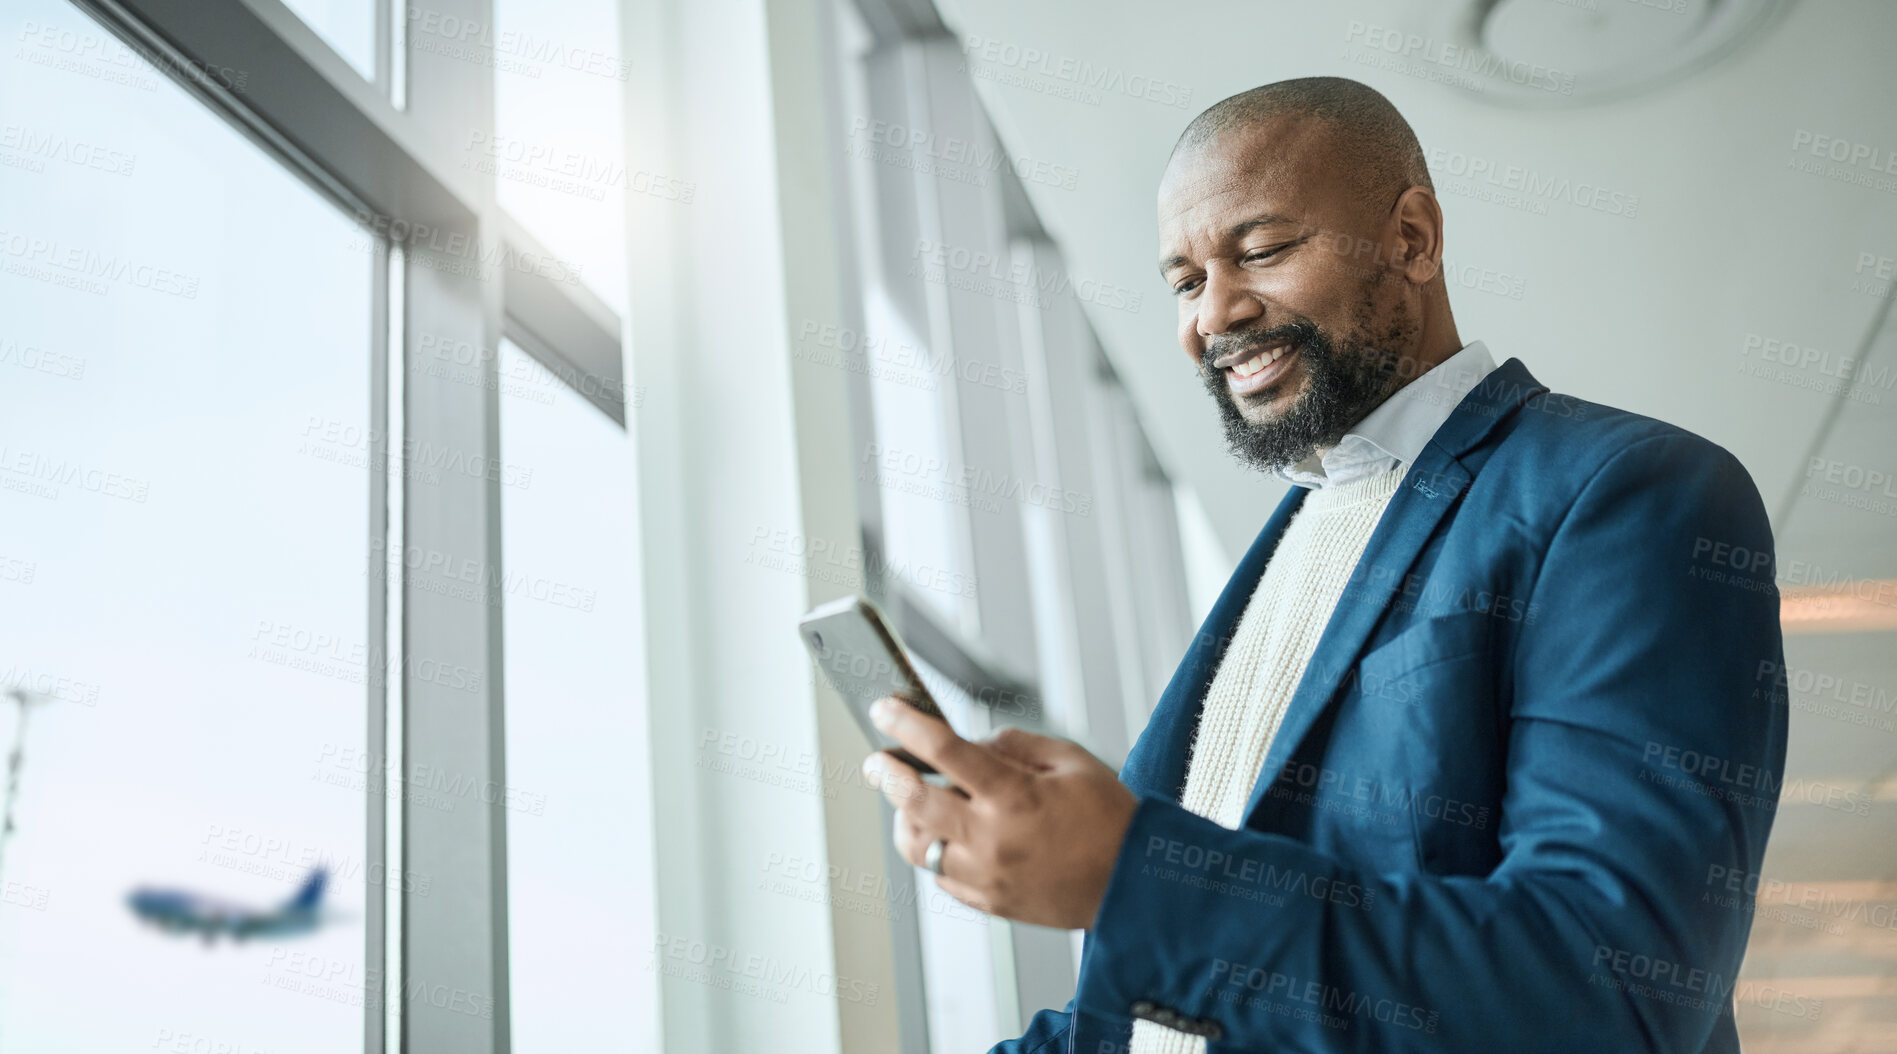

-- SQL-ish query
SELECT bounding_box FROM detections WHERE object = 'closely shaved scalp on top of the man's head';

[1172,78,1434,212]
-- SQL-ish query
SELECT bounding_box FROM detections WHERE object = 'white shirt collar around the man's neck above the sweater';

[1275,341,1495,489]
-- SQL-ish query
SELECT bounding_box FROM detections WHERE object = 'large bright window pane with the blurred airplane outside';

[0,0,373,1054]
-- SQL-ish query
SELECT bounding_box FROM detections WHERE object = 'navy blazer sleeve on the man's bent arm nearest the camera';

[1062,432,1787,1054]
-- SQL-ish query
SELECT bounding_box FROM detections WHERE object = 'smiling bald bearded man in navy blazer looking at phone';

[865,78,1787,1054]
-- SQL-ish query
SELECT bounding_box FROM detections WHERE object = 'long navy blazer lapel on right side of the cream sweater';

[1236,358,1548,821]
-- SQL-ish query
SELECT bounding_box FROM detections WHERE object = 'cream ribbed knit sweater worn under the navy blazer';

[1129,466,1404,1054]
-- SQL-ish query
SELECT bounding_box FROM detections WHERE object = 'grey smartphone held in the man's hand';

[797,597,949,775]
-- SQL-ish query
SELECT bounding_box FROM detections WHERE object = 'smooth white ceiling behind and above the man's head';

[939,0,1897,557]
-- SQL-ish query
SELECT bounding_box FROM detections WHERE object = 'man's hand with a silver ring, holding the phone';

[863,698,1138,929]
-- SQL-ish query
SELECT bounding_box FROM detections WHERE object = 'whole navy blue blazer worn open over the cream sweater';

[994,358,1787,1054]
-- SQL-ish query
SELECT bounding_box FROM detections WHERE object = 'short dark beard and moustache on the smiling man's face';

[1201,303,1413,470]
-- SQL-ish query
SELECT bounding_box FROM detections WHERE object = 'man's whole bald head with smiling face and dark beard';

[1159,78,1461,475]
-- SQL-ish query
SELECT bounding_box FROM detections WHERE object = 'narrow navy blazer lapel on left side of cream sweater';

[1119,487,1309,802]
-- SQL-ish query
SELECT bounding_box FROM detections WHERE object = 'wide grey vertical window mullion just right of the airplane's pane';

[398,0,510,1054]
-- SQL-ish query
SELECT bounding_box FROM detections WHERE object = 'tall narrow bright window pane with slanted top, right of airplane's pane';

[499,341,656,1054]
